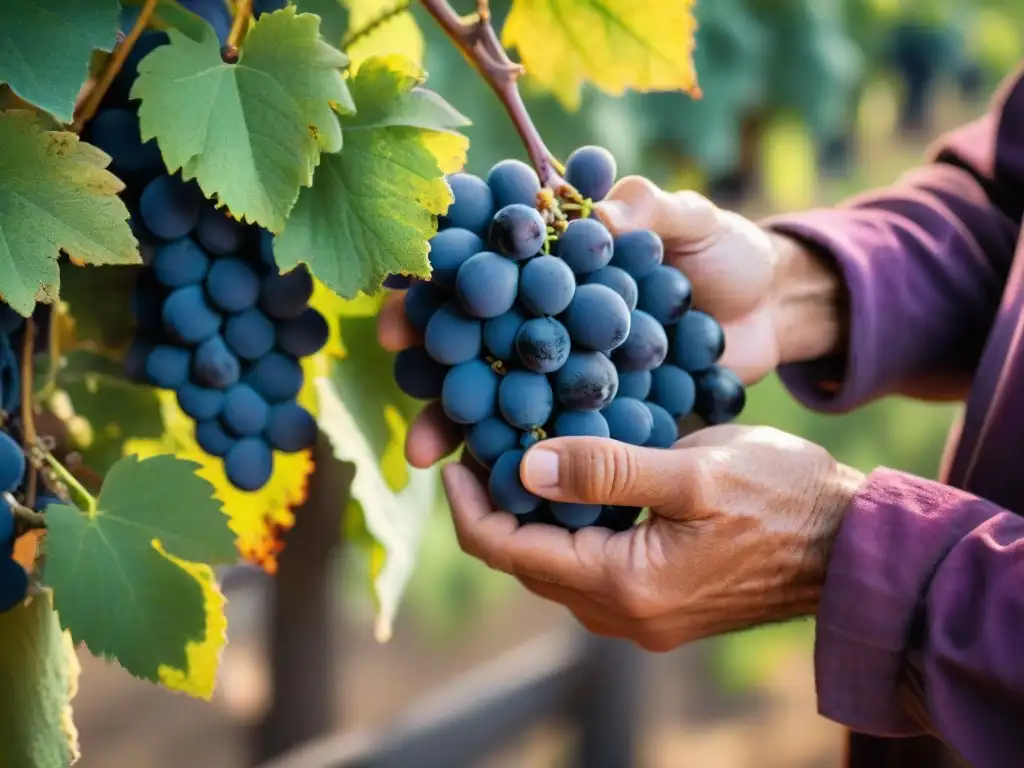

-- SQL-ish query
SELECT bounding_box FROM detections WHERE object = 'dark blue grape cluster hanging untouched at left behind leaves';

[86,32,328,490]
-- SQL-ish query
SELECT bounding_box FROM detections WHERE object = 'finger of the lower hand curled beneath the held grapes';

[442,464,611,594]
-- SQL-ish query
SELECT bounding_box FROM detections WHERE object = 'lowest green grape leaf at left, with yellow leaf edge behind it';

[44,456,238,682]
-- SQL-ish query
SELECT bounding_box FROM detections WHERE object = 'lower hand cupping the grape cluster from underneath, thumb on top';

[443,425,864,651]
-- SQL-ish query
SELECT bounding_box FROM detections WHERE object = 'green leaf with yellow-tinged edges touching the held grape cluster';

[274,55,469,298]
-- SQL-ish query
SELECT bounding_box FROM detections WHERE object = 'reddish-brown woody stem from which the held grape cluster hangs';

[422,0,565,190]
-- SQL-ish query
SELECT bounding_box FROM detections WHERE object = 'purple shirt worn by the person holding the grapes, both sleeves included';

[766,66,1024,768]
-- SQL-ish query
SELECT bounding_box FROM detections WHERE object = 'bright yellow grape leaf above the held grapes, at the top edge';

[502,0,697,111]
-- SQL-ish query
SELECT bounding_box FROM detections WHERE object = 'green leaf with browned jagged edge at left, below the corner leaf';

[0,112,141,316]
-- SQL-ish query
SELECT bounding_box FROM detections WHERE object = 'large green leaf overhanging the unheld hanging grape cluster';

[131,6,353,231]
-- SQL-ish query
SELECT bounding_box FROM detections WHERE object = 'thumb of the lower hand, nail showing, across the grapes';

[519,437,692,507]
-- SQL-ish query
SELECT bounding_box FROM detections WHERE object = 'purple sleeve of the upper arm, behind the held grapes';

[764,69,1024,412]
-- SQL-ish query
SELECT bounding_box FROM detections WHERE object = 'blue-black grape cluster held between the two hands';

[394,146,745,530]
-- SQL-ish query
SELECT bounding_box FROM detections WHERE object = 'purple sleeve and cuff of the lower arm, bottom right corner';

[815,469,1024,768]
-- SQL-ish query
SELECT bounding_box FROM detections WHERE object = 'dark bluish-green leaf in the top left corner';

[0,0,120,123]
